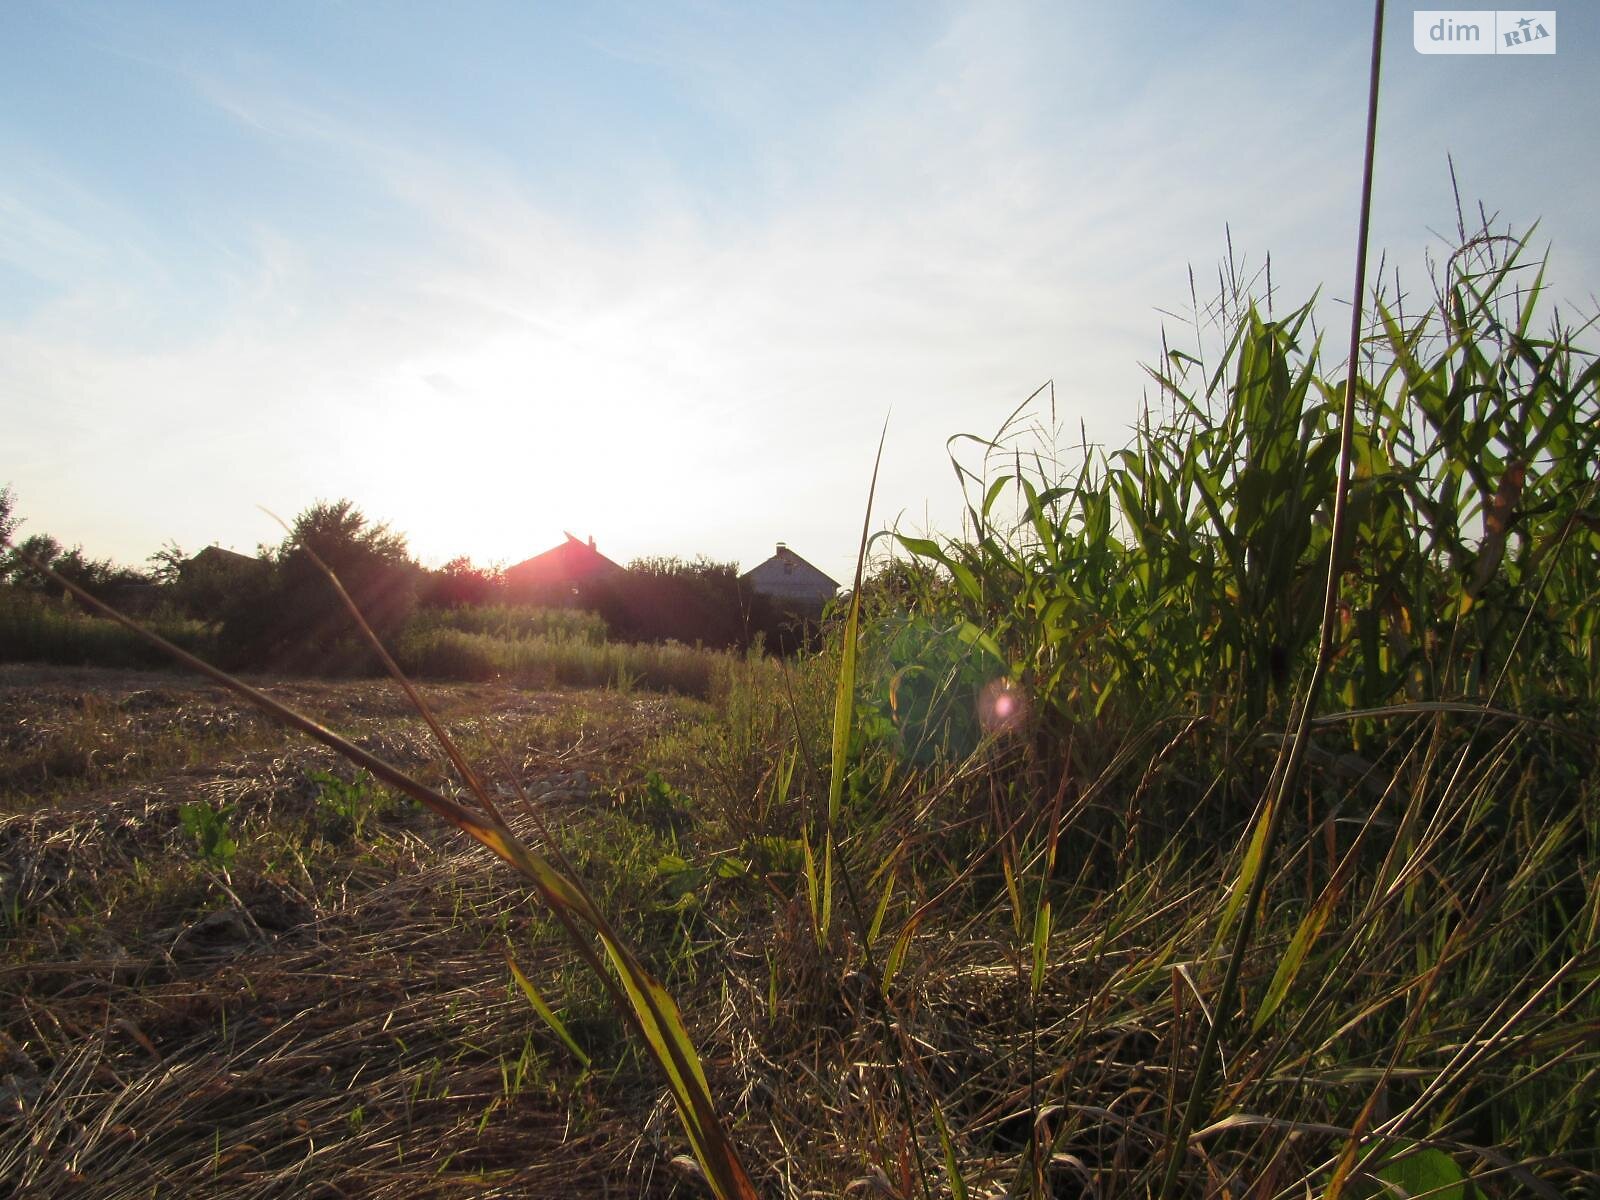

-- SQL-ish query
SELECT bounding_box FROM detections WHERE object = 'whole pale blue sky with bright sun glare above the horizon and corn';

[0,0,1600,581]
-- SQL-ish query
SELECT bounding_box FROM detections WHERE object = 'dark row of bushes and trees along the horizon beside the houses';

[0,488,816,672]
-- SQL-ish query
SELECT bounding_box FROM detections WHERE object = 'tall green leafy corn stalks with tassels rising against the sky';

[899,220,1600,742]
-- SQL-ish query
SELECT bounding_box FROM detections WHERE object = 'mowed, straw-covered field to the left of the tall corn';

[0,667,726,1195]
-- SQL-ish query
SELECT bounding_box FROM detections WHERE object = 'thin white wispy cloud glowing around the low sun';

[0,6,1600,574]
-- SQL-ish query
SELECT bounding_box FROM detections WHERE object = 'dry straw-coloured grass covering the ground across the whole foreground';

[0,652,1600,1197]
